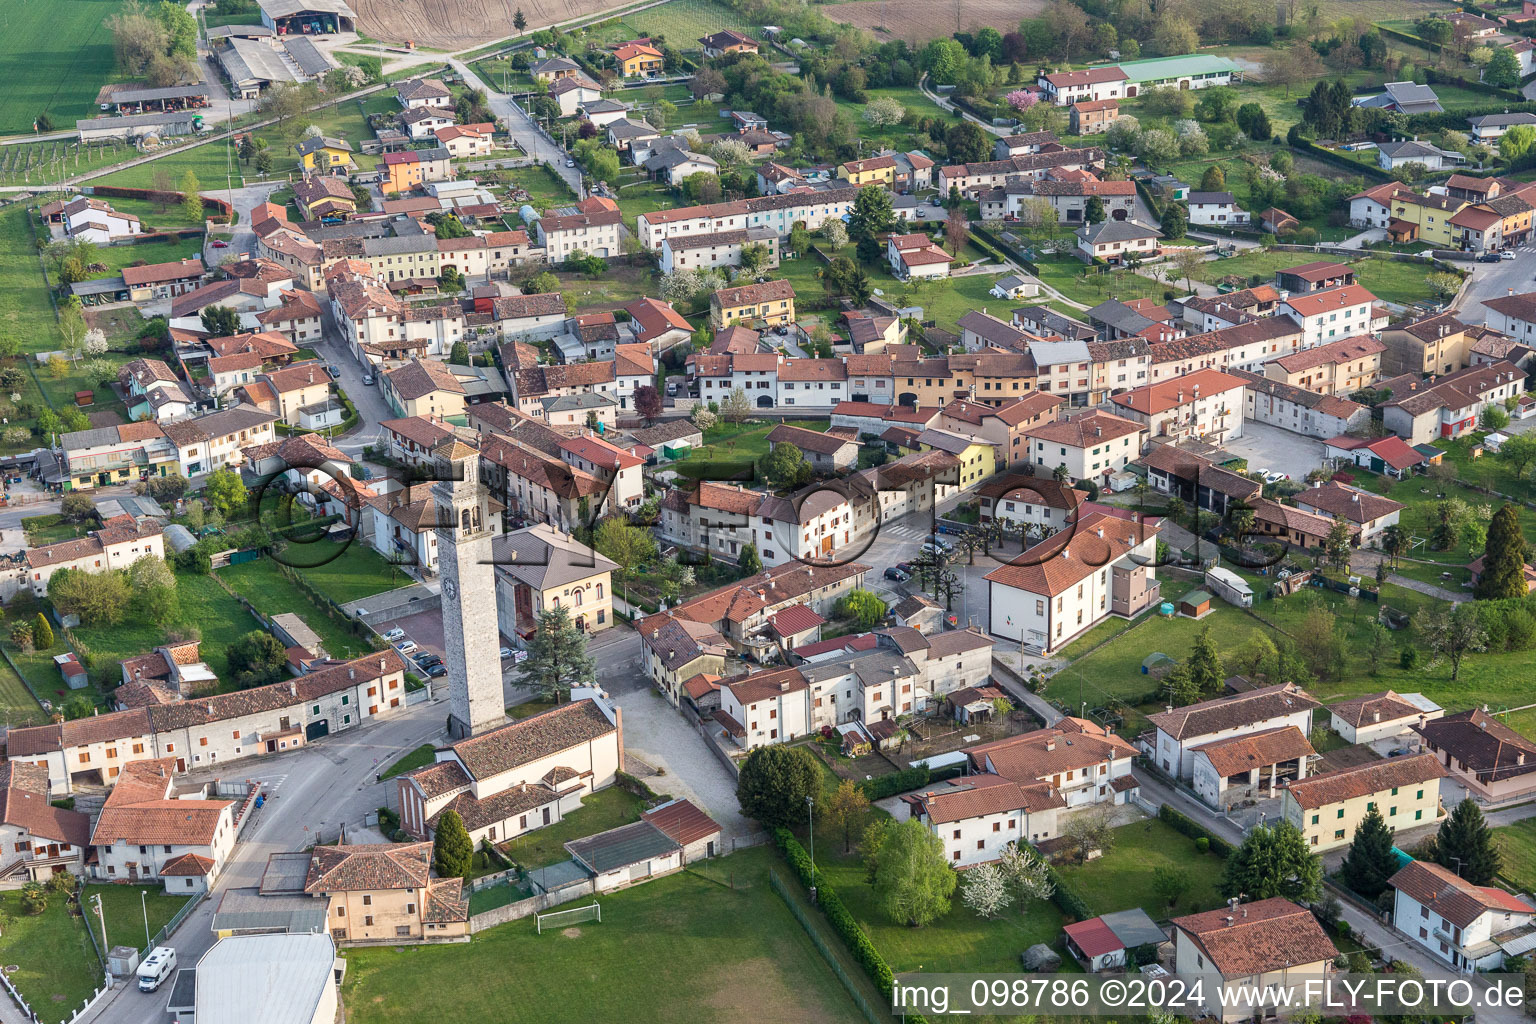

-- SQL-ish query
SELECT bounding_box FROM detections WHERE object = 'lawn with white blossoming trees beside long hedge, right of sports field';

[816,838,1077,973]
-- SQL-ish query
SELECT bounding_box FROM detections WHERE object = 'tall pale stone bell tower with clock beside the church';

[432,438,507,740]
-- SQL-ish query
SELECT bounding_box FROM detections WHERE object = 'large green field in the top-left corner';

[0,0,120,135]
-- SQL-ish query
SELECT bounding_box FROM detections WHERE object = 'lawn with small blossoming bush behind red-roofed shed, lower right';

[1057,818,1223,921]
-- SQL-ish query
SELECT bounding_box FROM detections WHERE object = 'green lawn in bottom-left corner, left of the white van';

[0,890,104,1024]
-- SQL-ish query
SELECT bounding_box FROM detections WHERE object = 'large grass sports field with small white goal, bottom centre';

[343,847,863,1024]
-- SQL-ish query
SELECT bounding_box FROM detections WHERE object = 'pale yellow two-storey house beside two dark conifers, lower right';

[1281,754,1447,852]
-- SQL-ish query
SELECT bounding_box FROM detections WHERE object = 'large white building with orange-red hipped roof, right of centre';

[986,513,1161,651]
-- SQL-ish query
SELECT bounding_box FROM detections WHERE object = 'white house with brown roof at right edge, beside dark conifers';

[1389,860,1536,973]
